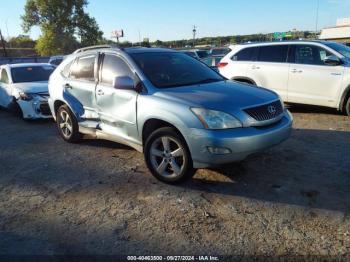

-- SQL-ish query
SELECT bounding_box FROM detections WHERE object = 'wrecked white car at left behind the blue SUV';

[0,64,55,119]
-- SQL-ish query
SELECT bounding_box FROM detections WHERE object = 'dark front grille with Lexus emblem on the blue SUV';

[244,101,283,121]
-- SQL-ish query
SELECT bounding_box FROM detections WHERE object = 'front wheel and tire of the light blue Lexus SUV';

[144,127,196,184]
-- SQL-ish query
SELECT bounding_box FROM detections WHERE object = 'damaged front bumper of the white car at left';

[17,97,52,119]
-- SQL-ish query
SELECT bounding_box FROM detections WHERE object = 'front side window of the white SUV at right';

[294,45,332,65]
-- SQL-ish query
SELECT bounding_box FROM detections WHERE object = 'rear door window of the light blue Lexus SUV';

[70,55,95,81]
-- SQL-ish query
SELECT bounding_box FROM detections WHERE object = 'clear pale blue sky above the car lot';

[0,0,350,42]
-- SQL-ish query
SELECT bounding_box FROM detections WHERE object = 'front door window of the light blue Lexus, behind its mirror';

[101,54,134,85]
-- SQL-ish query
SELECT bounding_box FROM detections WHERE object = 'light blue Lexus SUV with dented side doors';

[49,47,292,183]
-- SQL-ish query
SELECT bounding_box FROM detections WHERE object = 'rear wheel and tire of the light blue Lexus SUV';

[56,105,82,143]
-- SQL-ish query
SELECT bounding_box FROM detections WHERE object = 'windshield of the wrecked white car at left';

[11,65,55,83]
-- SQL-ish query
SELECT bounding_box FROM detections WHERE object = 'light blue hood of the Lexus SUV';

[154,81,278,113]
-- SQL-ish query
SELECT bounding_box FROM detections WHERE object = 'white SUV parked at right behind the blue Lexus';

[218,41,350,115]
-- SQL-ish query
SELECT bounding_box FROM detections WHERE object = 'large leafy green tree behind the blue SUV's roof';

[22,0,103,56]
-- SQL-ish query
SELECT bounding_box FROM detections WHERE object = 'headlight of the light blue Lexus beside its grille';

[191,108,242,129]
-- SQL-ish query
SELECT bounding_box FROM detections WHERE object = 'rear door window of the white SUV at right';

[258,45,288,63]
